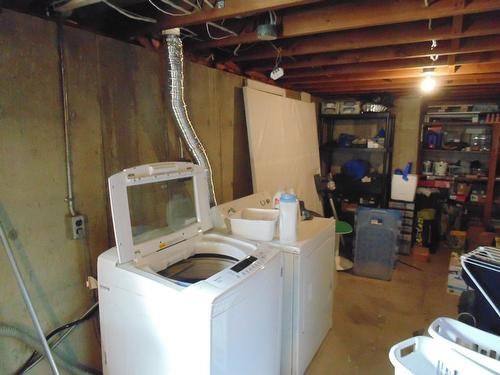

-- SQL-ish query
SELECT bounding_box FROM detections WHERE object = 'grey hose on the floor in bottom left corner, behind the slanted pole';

[0,323,100,375]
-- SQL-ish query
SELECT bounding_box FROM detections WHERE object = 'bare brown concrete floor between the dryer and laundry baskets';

[307,249,458,375]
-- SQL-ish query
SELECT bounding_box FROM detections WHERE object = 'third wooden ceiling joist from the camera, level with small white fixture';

[251,35,500,72]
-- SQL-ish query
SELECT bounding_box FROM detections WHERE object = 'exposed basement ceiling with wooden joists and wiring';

[3,0,500,96]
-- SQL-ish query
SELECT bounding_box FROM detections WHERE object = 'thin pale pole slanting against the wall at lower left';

[0,221,59,375]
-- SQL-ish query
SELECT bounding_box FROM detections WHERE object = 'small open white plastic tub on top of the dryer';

[229,208,279,241]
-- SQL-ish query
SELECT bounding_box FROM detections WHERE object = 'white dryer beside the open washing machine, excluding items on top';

[212,193,335,375]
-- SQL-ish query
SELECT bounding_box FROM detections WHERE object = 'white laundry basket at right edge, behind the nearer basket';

[428,318,500,374]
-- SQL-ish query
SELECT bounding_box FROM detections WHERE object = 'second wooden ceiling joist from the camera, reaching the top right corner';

[193,0,500,49]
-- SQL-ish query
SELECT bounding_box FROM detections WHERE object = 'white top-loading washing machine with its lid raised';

[98,163,283,375]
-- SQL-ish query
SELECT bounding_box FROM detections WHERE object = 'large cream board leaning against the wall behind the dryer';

[243,86,322,213]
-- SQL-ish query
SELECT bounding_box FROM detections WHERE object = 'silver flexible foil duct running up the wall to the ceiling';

[162,30,217,207]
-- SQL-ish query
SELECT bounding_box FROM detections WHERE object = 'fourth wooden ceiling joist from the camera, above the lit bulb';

[283,51,500,81]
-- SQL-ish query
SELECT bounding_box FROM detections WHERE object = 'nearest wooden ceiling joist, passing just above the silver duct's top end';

[134,0,320,36]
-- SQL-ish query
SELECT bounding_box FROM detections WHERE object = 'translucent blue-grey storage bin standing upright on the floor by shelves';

[353,207,401,280]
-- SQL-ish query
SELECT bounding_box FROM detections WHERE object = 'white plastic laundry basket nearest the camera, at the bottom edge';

[389,336,494,375]
